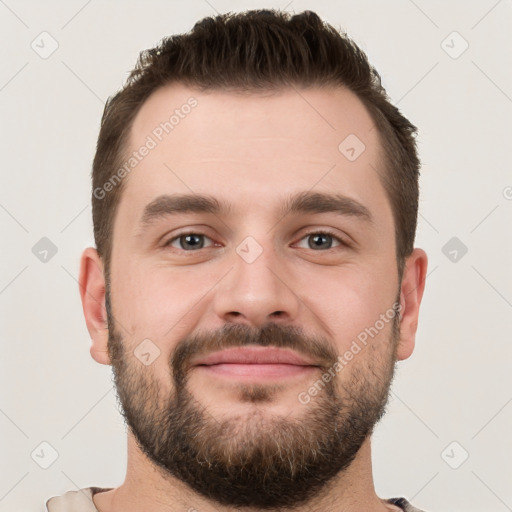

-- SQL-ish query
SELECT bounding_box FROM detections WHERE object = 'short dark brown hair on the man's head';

[92,9,420,283]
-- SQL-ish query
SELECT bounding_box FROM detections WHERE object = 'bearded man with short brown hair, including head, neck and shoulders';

[47,10,427,512]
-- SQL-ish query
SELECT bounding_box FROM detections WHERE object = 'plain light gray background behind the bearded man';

[0,0,512,512]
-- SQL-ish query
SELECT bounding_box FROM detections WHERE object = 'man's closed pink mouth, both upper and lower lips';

[193,346,319,379]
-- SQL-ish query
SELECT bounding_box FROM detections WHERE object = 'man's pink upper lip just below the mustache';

[192,347,317,366]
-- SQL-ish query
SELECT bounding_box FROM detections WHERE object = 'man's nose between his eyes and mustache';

[214,239,303,328]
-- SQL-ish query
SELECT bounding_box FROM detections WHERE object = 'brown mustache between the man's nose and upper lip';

[170,322,338,380]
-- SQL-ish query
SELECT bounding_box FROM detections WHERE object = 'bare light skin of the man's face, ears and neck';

[79,84,427,512]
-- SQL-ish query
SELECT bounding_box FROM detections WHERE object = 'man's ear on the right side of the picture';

[397,249,428,361]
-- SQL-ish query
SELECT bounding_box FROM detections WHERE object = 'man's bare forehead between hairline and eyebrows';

[114,84,390,232]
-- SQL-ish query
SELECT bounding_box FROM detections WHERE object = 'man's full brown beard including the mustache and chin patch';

[106,287,400,510]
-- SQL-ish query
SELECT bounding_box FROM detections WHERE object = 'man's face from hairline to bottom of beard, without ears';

[107,85,399,509]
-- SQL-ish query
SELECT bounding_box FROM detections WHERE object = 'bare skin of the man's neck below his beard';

[93,429,399,512]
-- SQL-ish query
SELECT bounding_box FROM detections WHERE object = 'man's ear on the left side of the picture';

[79,247,110,365]
